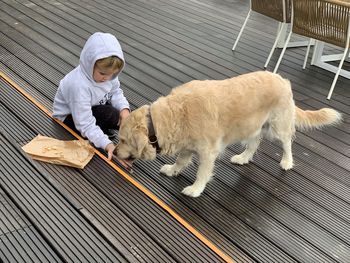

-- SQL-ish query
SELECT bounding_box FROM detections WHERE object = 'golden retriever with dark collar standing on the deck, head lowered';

[115,71,341,197]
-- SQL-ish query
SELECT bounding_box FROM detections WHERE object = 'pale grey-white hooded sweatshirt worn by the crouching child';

[53,32,130,149]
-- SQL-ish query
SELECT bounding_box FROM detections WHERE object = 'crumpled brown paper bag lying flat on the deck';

[22,135,95,169]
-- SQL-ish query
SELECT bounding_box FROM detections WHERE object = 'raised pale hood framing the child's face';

[79,32,125,83]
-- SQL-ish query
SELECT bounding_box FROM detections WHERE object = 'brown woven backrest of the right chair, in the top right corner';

[292,0,350,48]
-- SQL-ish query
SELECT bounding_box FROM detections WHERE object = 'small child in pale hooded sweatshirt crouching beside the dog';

[53,32,130,166]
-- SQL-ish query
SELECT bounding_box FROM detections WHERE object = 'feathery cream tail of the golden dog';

[295,107,342,130]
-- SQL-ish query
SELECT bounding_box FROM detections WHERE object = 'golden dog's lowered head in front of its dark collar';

[114,106,156,160]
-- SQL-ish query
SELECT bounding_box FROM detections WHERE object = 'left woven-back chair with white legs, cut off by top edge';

[232,0,290,68]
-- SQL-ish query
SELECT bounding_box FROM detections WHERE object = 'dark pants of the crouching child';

[63,104,119,134]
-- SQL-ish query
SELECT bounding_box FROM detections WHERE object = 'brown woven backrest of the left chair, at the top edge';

[250,0,291,23]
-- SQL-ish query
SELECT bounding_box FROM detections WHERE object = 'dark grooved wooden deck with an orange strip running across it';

[0,0,350,263]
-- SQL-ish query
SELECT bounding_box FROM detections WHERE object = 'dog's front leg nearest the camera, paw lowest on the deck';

[182,151,219,197]
